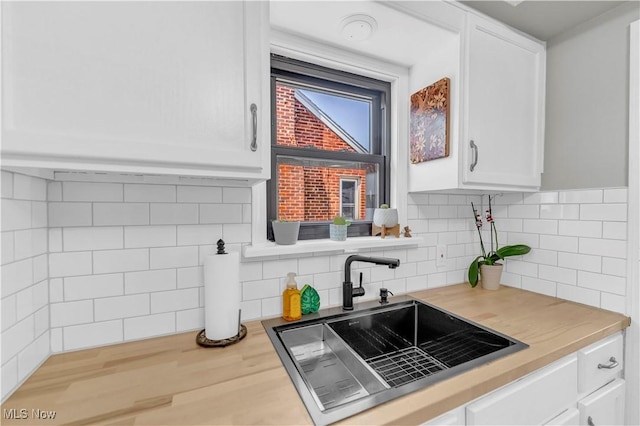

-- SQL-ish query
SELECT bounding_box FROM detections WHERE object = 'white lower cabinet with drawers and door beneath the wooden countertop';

[423,332,625,426]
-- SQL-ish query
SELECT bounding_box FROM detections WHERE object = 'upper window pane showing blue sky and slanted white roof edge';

[276,81,371,153]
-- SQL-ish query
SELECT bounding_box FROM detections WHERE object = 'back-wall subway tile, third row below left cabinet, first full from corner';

[62,226,124,252]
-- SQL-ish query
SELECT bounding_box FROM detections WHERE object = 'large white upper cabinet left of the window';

[2,1,270,183]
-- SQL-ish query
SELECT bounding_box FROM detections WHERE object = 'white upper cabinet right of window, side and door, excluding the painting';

[409,12,546,192]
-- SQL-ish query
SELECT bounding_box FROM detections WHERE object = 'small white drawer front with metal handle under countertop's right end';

[578,333,624,394]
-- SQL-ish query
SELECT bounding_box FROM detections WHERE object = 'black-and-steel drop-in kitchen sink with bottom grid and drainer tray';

[262,298,528,424]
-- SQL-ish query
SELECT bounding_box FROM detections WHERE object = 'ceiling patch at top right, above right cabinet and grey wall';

[460,0,637,41]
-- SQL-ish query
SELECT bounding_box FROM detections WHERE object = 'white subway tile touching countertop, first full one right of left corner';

[63,320,123,351]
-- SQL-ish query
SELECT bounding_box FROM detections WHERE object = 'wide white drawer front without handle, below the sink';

[467,354,578,425]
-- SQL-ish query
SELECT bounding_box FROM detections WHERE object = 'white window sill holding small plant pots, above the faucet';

[242,236,424,259]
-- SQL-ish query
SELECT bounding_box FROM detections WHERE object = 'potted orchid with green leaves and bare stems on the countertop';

[468,196,531,290]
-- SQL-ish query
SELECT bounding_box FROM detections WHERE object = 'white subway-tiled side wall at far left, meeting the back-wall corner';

[0,171,50,400]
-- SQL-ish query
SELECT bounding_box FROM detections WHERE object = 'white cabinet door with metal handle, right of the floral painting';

[462,14,545,188]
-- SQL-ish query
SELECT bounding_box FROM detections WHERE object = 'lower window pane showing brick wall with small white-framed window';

[276,155,379,222]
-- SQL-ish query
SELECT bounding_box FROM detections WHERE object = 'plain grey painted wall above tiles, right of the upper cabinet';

[542,1,640,190]
